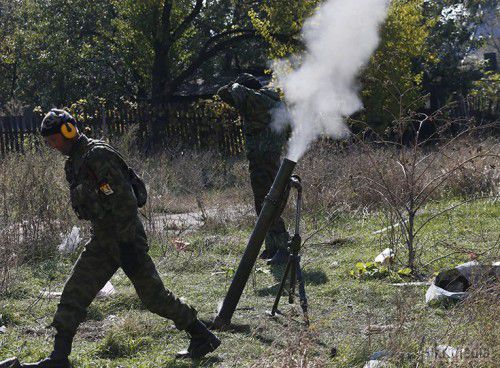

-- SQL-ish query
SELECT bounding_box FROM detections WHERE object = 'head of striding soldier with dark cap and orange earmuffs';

[40,109,80,155]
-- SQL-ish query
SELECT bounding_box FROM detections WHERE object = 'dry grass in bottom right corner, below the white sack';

[373,281,500,368]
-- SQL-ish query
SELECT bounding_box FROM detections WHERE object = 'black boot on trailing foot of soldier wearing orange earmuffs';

[177,319,220,359]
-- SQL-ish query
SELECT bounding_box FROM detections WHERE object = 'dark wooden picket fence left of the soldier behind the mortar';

[0,103,244,157]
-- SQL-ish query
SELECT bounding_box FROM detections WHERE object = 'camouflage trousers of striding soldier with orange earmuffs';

[52,217,197,336]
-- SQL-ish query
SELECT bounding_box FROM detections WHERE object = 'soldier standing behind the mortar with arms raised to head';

[217,73,289,265]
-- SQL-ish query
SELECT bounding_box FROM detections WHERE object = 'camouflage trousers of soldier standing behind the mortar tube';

[248,153,289,253]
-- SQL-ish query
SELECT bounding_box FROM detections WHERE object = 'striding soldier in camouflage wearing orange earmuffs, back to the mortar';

[23,109,220,368]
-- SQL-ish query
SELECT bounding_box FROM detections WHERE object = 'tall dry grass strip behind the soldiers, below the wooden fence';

[0,130,500,291]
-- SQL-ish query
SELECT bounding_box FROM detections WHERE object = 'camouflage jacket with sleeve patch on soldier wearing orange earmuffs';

[65,134,137,237]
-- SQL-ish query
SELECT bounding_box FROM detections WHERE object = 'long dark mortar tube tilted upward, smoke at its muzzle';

[213,158,297,329]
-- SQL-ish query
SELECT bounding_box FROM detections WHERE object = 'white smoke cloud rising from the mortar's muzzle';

[273,0,389,161]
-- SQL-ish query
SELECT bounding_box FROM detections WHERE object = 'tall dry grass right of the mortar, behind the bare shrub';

[298,137,500,216]
